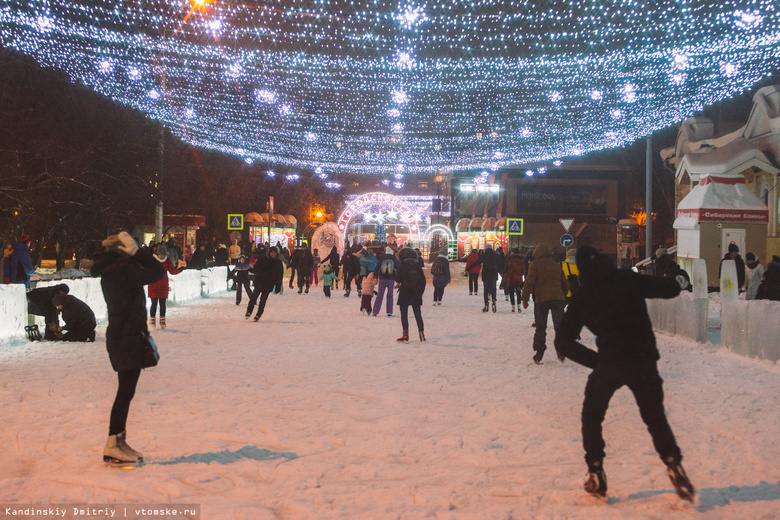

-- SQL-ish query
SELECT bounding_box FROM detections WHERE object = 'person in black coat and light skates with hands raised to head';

[92,231,166,463]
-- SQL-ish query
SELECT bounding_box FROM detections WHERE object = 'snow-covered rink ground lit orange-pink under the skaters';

[0,278,780,520]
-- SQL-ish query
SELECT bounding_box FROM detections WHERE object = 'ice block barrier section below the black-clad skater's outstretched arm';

[647,292,709,343]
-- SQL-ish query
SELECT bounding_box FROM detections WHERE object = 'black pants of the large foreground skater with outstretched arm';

[582,363,682,471]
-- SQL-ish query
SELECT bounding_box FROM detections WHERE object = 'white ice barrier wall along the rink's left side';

[0,266,228,345]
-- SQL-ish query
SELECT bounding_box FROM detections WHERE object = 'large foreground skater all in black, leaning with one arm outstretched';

[555,246,694,499]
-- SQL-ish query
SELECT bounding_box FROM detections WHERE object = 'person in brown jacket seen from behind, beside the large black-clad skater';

[522,244,569,365]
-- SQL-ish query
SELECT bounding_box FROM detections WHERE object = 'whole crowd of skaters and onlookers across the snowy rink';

[9,233,780,500]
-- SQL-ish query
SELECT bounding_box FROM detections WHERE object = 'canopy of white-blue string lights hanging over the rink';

[0,0,780,177]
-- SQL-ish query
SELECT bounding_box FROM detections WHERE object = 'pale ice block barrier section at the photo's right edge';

[720,300,780,362]
